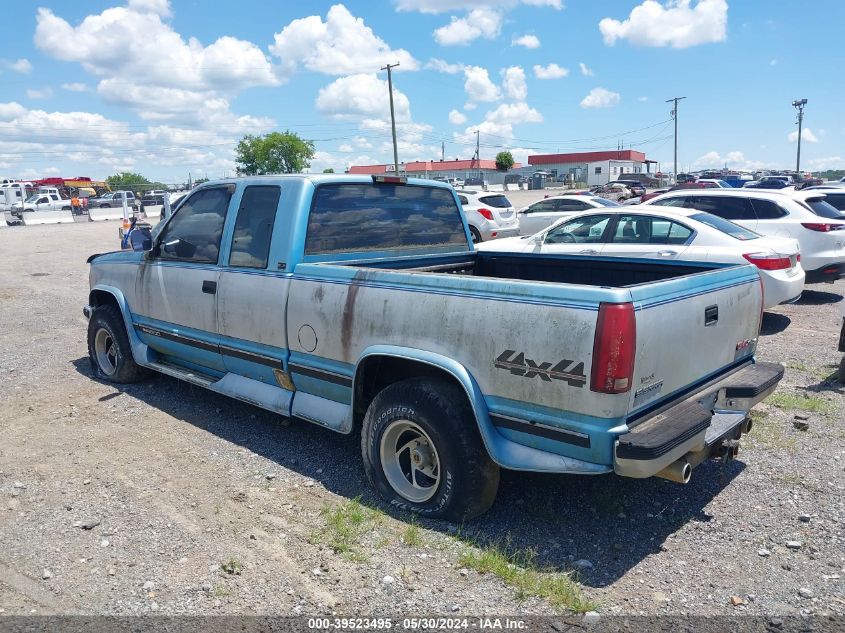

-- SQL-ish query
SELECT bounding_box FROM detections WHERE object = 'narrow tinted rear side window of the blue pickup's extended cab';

[229,186,282,268]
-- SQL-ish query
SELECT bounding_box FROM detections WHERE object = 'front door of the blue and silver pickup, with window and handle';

[132,185,235,372]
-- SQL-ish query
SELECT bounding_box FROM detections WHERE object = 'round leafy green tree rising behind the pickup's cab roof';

[235,130,315,176]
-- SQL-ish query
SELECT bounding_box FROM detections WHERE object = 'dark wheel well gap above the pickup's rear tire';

[353,356,464,426]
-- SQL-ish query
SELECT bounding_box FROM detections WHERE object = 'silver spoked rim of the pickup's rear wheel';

[379,420,440,503]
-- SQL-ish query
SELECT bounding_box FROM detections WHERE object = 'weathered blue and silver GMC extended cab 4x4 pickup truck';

[83,175,783,520]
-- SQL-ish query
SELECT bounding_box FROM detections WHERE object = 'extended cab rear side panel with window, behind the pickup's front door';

[217,184,290,390]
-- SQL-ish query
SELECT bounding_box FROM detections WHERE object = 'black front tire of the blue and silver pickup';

[88,305,150,384]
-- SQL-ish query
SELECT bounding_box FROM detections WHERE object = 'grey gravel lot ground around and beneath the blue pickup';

[0,218,845,616]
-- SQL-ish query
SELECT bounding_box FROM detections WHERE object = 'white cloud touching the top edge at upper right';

[599,0,728,48]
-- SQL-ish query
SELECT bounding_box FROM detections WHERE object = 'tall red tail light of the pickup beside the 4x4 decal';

[590,302,637,393]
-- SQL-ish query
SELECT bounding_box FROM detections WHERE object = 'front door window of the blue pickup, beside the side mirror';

[159,186,234,264]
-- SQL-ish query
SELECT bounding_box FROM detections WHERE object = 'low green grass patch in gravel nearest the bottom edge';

[459,545,595,613]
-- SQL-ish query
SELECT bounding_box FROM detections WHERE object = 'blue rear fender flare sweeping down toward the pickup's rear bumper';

[352,345,610,474]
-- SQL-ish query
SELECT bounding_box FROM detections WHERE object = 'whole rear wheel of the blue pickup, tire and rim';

[361,378,499,522]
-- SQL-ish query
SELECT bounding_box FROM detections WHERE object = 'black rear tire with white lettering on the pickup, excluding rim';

[361,378,499,522]
